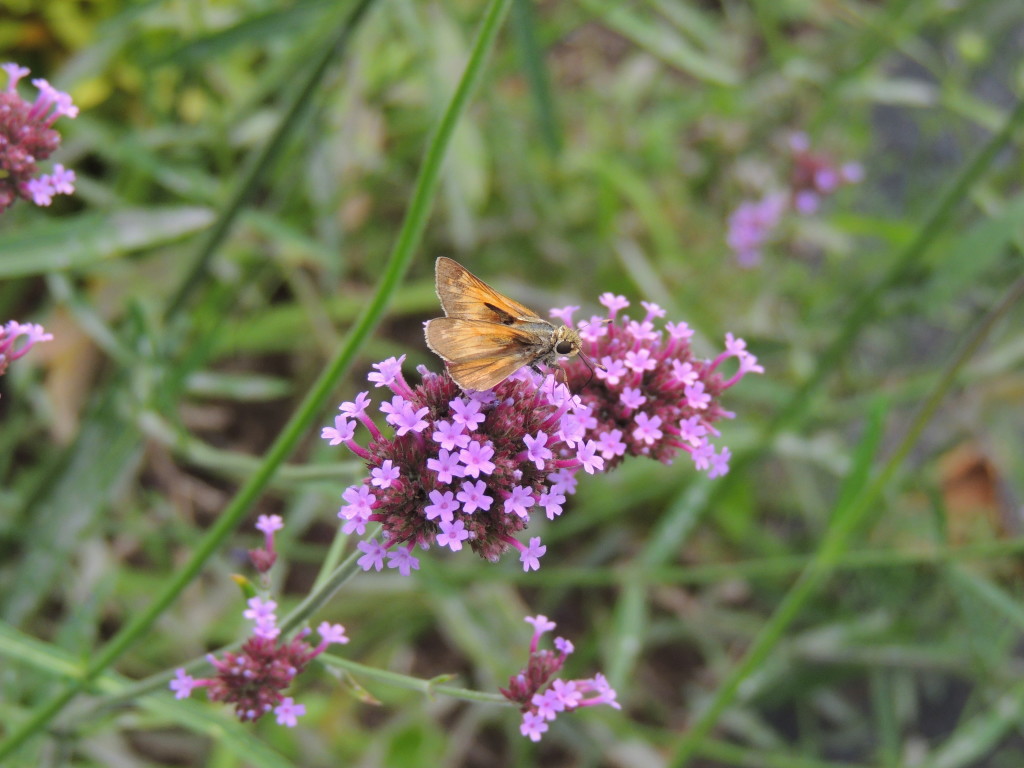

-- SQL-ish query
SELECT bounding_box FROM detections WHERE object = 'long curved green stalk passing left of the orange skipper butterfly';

[0,0,511,760]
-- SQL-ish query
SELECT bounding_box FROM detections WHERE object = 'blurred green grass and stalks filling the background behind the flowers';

[0,0,1024,768]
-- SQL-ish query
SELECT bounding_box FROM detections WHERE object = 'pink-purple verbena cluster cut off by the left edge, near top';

[0,63,78,213]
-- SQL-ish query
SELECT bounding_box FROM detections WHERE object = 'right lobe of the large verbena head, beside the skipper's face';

[551,293,764,477]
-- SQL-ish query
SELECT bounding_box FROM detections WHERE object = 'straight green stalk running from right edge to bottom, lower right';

[670,278,1024,766]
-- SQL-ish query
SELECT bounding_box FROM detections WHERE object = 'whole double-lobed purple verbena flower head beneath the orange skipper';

[322,294,763,574]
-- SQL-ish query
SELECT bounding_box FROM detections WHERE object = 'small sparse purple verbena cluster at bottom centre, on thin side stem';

[499,615,622,741]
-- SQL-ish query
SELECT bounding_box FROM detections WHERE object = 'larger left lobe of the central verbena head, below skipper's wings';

[322,355,604,574]
